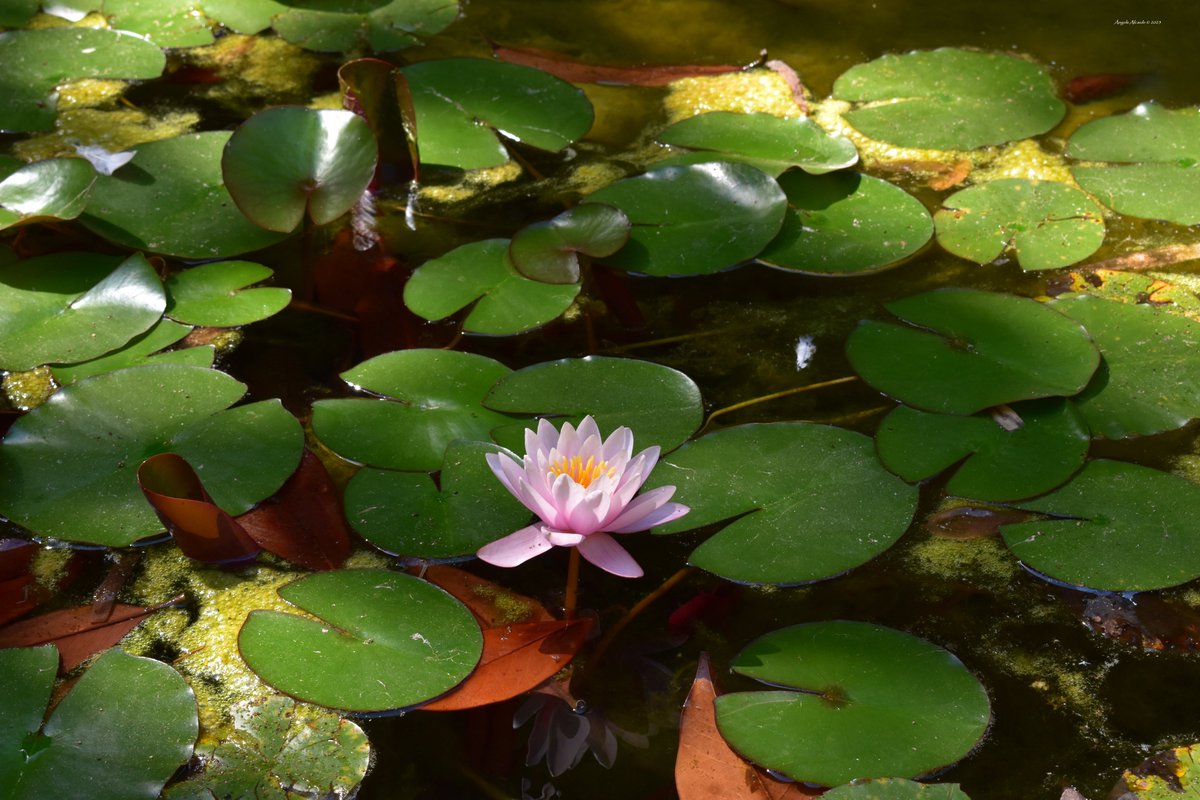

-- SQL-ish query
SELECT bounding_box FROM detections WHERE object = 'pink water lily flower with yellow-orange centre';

[479,416,689,578]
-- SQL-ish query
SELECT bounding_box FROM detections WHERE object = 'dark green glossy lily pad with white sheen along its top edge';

[586,162,787,276]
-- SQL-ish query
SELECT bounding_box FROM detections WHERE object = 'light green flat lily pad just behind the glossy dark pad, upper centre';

[659,112,858,176]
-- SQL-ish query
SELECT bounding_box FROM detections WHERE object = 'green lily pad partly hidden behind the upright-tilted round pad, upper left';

[79,131,283,259]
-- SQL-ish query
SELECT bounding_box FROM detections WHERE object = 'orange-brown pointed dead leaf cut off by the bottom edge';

[676,654,822,800]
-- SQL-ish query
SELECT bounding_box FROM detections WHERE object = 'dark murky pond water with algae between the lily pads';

[7,0,1200,800]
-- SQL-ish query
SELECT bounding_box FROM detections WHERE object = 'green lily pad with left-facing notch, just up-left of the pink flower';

[312,350,512,470]
